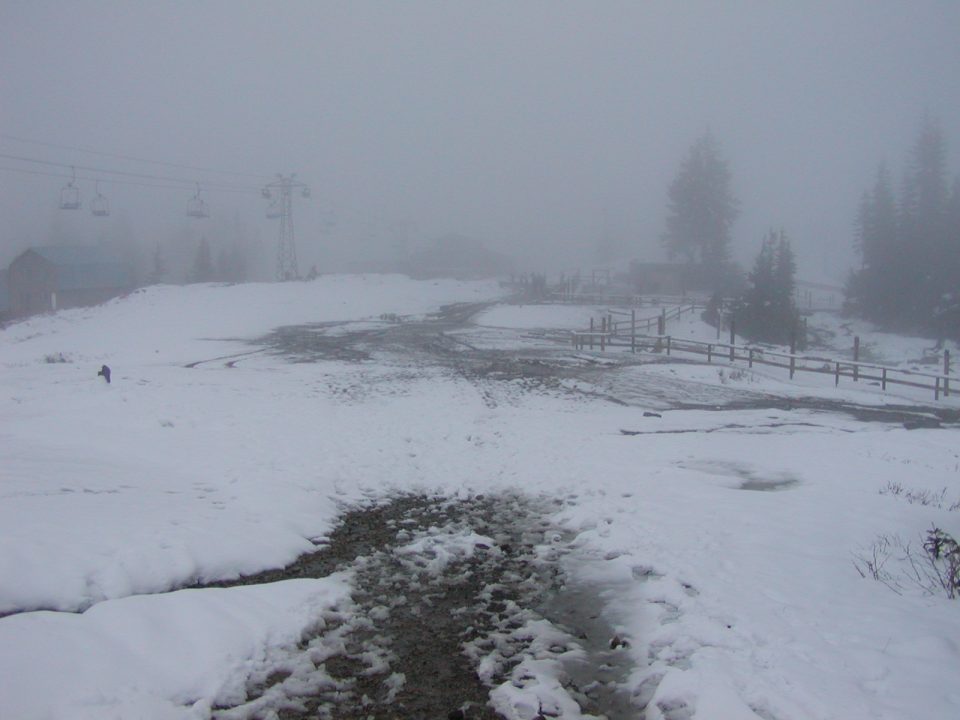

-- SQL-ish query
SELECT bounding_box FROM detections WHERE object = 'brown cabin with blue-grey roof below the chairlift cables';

[7,245,131,317]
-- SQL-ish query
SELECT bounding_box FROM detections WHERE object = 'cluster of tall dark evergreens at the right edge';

[846,117,960,339]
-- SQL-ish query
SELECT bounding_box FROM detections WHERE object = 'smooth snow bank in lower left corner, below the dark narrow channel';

[0,576,349,720]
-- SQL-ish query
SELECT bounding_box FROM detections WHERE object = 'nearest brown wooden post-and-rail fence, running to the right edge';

[571,305,960,400]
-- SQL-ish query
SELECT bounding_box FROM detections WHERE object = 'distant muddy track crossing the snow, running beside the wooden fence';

[249,302,960,427]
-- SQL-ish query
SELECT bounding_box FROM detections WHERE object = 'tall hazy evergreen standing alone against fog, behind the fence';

[662,133,738,284]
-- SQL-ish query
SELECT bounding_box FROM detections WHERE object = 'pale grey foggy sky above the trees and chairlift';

[0,0,960,279]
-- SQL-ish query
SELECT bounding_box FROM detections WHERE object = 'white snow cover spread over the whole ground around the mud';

[0,276,960,720]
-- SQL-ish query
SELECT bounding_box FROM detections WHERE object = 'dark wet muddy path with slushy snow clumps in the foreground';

[208,494,639,720]
